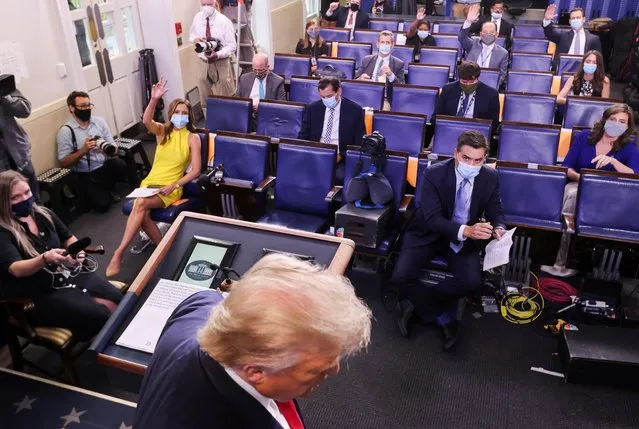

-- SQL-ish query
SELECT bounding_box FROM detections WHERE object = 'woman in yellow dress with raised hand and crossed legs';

[106,78,202,277]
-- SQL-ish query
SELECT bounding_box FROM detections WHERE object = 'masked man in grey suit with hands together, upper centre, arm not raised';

[355,30,404,110]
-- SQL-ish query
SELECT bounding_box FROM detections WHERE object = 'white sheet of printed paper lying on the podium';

[115,279,207,353]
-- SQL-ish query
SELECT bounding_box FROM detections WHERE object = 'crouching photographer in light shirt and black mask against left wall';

[57,91,126,213]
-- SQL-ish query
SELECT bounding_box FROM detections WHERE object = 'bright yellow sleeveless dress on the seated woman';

[140,127,191,207]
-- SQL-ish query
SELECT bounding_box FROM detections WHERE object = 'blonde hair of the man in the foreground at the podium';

[198,254,371,372]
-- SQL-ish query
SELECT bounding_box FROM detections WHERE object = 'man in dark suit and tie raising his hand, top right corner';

[542,4,602,63]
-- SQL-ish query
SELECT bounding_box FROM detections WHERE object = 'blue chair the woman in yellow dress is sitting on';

[122,131,209,223]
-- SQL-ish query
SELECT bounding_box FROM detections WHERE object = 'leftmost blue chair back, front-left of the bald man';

[206,95,253,133]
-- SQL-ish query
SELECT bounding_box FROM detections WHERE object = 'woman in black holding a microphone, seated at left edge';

[0,171,122,341]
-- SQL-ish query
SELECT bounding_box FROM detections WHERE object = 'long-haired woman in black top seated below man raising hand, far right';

[557,51,610,104]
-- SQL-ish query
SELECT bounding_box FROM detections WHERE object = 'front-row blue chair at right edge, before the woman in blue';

[575,170,639,243]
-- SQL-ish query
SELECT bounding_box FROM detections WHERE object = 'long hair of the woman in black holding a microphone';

[0,170,53,258]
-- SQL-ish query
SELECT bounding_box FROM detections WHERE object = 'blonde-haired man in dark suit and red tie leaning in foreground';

[133,255,371,429]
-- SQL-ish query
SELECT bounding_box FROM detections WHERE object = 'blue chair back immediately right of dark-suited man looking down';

[373,111,426,156]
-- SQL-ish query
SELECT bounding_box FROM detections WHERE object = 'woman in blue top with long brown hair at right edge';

[542,104,639,277]
